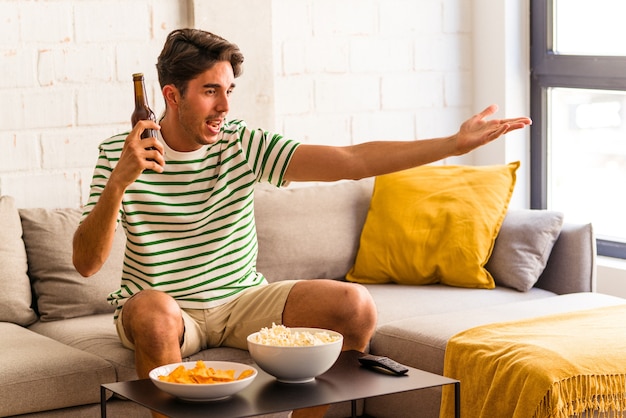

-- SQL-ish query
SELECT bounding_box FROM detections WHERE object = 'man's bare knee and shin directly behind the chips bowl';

[122,290,184,418]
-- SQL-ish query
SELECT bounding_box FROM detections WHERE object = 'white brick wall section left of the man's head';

[0,0,190,207]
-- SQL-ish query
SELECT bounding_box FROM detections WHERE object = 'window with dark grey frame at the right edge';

[531,0,626,258]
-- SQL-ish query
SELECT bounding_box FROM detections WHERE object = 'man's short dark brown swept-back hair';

[156,29,243,95]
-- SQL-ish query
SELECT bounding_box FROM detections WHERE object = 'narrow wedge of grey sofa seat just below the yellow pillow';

[365,283,555,327]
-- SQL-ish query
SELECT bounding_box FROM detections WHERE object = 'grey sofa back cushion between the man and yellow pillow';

[255,179,373,282]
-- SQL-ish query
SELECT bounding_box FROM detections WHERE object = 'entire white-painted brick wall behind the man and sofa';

[0,0,473,207]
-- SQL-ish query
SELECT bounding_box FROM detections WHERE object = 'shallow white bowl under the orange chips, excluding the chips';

[149,361,258,402]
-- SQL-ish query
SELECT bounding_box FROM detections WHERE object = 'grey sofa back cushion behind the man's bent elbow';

[19,208,126,321]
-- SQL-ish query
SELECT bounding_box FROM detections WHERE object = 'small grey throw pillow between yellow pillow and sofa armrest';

[485,209,563,292]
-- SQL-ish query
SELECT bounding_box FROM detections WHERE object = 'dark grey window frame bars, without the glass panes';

[530,0,626,259]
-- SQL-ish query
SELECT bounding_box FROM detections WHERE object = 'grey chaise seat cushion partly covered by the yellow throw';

[366,289,625,418]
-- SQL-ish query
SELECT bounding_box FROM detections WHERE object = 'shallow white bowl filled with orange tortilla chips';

[149,360,258,402]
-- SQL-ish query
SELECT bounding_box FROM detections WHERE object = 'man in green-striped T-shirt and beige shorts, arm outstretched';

[74,29,530,417]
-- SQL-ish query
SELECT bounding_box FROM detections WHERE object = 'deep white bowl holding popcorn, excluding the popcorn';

[248,328,343,383]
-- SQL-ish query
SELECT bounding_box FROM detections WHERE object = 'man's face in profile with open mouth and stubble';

[171,61,235,151]
